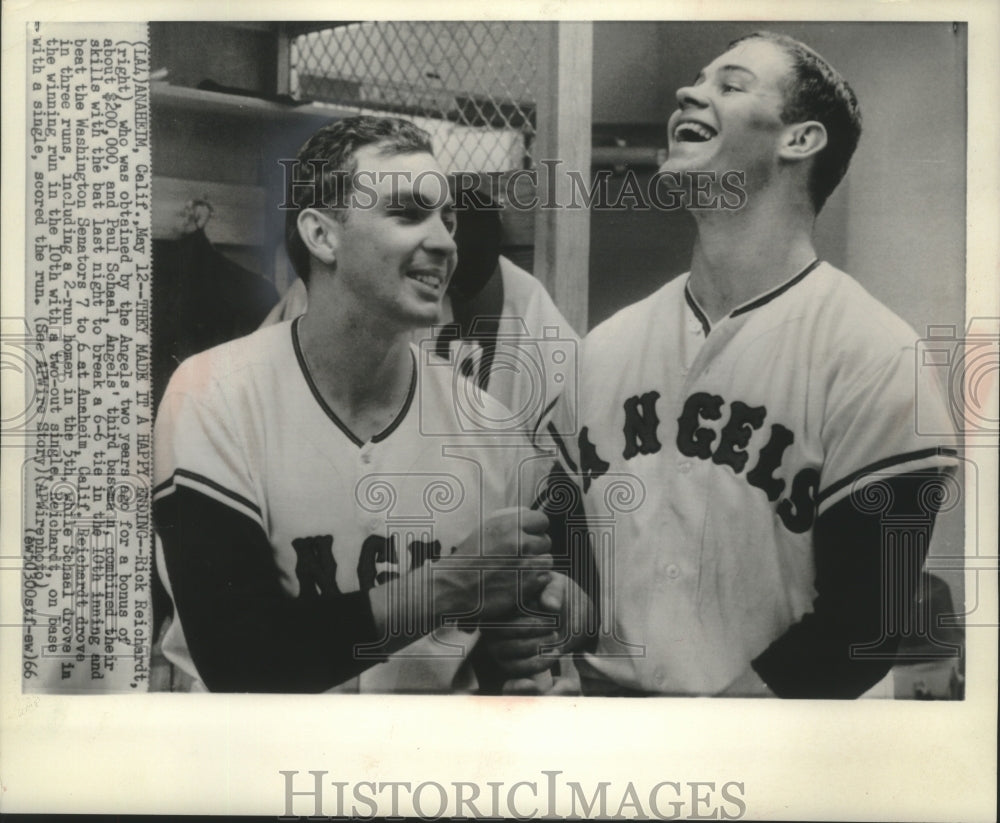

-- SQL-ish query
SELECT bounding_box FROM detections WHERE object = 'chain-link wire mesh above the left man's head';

[289,21,540,173]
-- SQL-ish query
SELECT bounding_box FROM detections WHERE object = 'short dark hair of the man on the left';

[285,115,434,283]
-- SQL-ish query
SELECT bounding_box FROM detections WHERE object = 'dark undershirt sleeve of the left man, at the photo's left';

[153,485,385,693]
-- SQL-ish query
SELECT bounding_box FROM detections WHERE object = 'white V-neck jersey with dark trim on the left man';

[154,321,537,692]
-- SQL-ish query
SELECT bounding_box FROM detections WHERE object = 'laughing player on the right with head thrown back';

[540,33,954,698]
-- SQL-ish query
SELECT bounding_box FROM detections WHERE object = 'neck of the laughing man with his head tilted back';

[690,192,816,323]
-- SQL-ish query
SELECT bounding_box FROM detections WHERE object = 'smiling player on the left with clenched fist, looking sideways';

[154,117,562,692]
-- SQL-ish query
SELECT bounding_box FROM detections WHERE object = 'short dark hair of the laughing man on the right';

[729,31,861,213]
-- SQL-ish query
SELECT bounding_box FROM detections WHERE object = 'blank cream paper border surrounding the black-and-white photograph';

[0,0,1000,820]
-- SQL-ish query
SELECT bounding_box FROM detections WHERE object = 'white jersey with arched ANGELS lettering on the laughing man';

[551,263,954,694]
